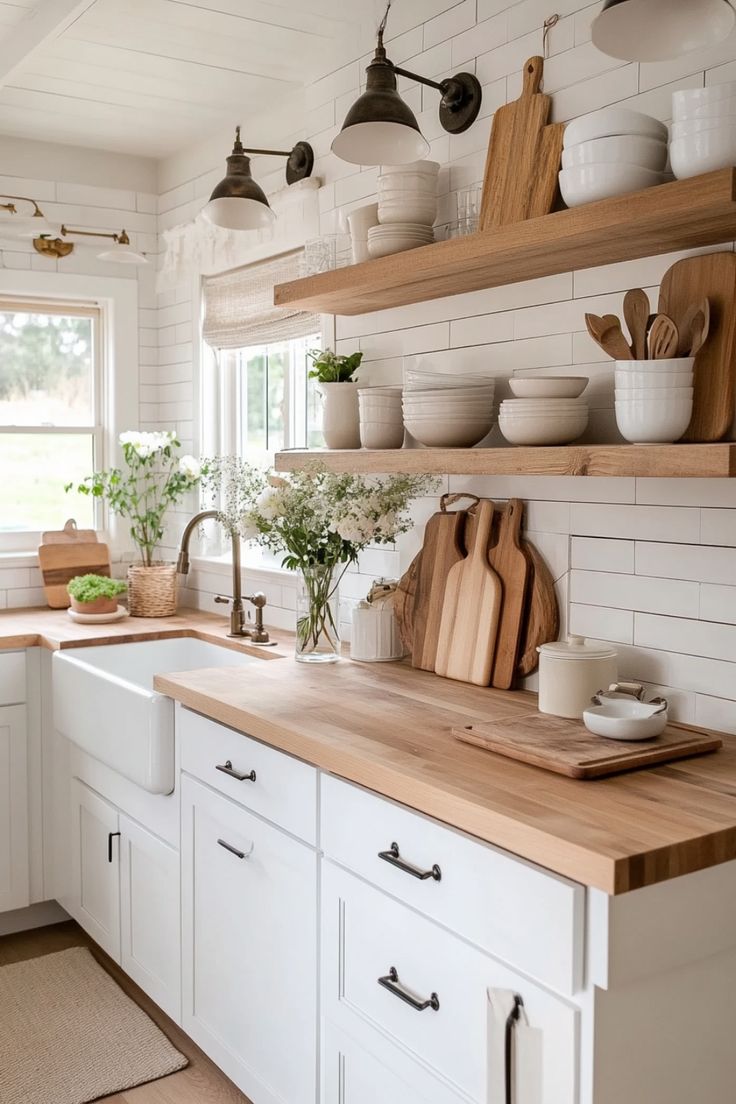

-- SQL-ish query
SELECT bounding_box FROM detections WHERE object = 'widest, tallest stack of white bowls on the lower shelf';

[403,369,495,448]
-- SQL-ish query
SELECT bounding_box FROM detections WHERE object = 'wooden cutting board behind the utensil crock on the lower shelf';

[659,253,736,442]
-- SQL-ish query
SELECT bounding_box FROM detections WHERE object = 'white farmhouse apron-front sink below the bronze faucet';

[53,637,258,794]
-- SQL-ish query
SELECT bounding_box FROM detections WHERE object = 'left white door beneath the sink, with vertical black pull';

[67,778,120,963]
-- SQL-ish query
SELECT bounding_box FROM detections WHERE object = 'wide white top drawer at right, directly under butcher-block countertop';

[321,776,585,994]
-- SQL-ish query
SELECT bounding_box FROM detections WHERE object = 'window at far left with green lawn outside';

[0,297,103,532]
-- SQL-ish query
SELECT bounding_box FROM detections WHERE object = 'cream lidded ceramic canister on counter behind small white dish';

[536,636,618,718]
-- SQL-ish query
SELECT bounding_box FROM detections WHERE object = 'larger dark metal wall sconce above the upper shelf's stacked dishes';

[332,0,481,164]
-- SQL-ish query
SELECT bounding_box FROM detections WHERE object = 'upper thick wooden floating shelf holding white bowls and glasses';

[274,169,736,315]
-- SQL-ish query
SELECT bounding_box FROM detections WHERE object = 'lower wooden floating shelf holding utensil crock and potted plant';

[276,442,736,479]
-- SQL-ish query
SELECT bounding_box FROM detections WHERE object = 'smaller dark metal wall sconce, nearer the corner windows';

[202,127,314,230]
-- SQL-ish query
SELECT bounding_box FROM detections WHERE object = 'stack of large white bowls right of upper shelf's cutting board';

[559,109,676,206]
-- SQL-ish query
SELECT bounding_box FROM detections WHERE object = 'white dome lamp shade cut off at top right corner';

[593,0,736,62]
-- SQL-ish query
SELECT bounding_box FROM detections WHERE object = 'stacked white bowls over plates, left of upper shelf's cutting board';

[369,161,439,257]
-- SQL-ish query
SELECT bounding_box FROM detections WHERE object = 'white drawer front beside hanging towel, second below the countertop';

[322,862,578,1104]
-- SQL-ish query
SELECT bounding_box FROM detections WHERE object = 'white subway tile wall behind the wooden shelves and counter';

[0,0,736,732]
